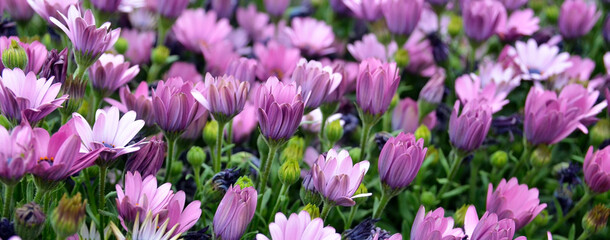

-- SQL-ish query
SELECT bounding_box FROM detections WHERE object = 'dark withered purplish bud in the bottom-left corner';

[15,202,47,240]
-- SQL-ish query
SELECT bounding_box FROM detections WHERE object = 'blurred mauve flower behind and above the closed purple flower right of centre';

[392,98,437,133]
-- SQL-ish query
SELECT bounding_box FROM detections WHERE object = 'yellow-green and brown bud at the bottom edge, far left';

[51,193,87,239]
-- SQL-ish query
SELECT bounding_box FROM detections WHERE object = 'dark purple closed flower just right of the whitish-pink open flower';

[125,135,167,176]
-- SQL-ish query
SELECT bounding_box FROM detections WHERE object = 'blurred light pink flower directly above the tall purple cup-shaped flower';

[347,33,398,62]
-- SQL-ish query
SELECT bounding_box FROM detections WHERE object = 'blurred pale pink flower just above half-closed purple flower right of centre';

[455,73,509,113]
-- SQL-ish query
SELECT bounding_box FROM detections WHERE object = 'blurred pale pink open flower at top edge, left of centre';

[172,9,231,53]
